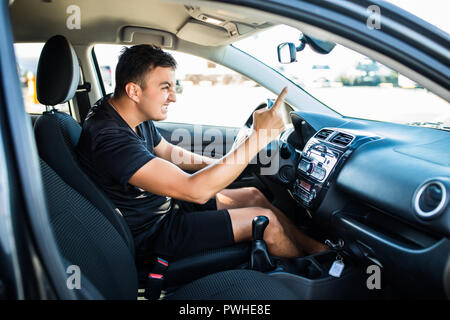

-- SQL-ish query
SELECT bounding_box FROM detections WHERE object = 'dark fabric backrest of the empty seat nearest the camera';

[41,160,138,300]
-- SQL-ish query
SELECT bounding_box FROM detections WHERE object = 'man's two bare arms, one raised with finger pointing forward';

[133,88,287,203]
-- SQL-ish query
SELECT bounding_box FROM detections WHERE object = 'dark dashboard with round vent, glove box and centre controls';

[268,112,450,297]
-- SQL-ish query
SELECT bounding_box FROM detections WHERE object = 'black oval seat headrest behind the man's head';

[36,35,80,106]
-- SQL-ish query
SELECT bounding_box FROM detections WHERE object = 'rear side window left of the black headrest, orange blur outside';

[14,43,69,114]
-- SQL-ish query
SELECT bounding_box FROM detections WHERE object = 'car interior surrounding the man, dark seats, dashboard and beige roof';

[4,0,450,300]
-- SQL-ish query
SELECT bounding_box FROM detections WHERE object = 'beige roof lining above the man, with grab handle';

[10,0,270,46]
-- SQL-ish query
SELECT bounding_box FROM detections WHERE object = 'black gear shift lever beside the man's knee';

[250,216,274,272]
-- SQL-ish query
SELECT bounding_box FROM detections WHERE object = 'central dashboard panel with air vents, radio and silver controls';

[291,129,355,209]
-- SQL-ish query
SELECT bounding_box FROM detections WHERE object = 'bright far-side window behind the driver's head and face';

[94,45,275,127]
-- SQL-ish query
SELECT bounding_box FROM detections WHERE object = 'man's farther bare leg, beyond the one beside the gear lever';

[216,188,329,254]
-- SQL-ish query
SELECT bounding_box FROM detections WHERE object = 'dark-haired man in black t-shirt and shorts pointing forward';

[77,45,327,257]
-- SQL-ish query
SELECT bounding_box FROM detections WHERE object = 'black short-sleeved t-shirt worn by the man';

[77,96,172,242]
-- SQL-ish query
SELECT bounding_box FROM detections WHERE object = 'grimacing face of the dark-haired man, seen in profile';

[138,67,176,121]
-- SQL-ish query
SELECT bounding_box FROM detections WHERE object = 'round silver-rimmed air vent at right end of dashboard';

[414,180,447,218]
